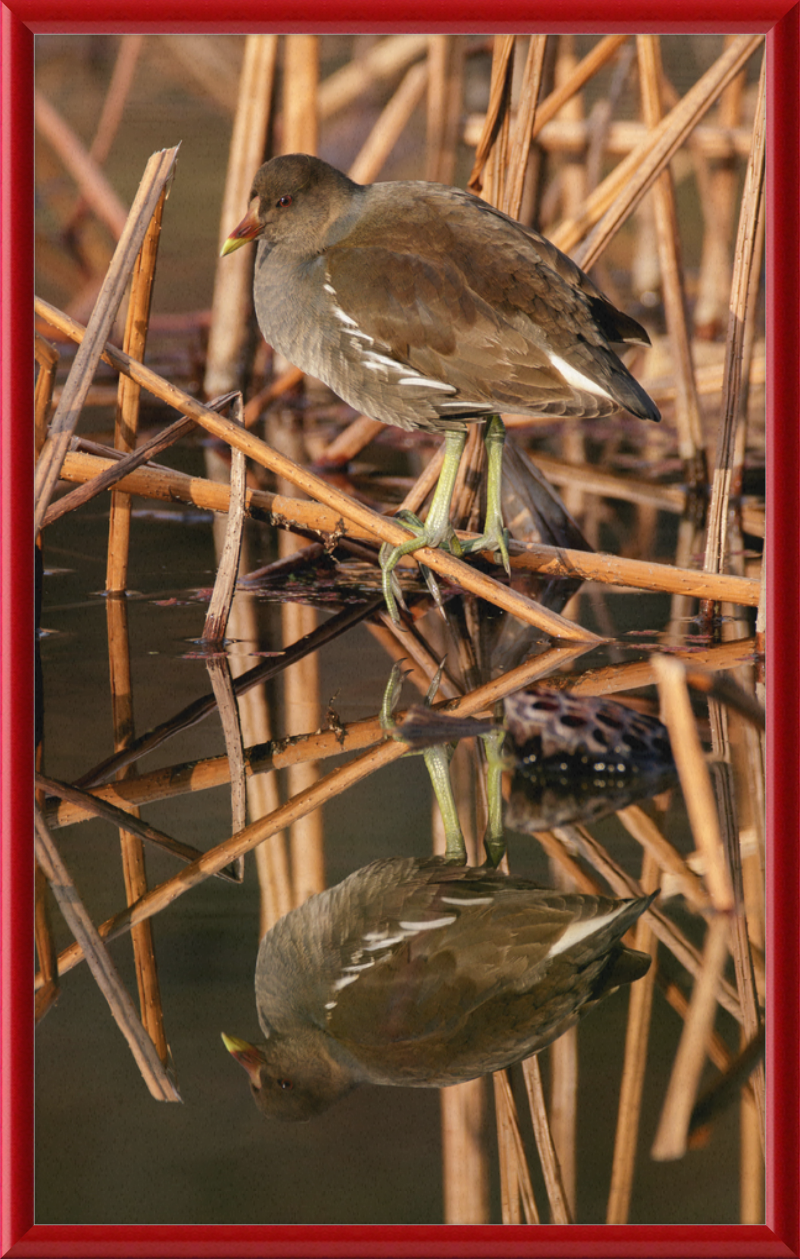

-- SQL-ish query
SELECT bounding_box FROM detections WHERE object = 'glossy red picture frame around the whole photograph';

[0,0,800,1256]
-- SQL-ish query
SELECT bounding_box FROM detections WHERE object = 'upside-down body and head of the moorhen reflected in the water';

[223,857,655,1121]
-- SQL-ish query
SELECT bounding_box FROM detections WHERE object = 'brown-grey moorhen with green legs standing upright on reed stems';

[222,154,660,621]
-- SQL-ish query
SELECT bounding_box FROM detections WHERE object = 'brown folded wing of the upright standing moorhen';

[325,194,658,419]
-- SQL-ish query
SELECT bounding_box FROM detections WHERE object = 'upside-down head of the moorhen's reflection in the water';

[222,1032,358,1123]
